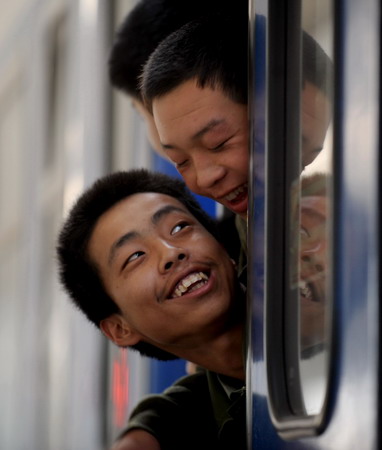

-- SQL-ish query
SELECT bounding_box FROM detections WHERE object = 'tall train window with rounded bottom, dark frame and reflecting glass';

[266,0,334,438]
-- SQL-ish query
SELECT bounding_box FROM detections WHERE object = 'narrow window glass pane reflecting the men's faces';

[289,0,333,415]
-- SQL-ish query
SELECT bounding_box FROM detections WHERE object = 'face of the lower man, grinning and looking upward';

[88,193,235,354]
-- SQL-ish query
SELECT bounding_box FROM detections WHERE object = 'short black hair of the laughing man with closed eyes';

[141,9,248,110]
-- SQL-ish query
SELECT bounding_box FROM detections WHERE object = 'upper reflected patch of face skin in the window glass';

[301,81,331,168]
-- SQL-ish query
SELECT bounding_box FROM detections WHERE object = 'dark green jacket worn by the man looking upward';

[125,369,246,450]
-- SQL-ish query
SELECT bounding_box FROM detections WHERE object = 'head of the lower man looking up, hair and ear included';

[57,169,237,359]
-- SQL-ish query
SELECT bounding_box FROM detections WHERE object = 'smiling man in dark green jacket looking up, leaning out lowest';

[57,169,246,449]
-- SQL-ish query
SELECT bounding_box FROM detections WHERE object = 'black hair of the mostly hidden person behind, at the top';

[108,0,247,100]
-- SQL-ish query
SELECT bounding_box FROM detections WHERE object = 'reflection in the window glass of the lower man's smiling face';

[300,196,328,351]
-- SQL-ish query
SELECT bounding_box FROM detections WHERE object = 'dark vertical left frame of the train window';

[266,0,304,422]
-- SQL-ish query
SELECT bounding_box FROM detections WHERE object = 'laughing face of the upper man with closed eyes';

[153,80,249,218]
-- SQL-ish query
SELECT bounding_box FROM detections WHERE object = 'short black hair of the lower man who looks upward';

[56,169,217,360]
